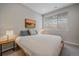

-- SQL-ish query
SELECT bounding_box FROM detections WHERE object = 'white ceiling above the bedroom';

[23,3,72,15]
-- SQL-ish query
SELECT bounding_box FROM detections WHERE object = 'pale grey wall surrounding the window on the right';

[44,4,79,43]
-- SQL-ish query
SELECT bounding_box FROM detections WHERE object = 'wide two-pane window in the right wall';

[44,12,67,30]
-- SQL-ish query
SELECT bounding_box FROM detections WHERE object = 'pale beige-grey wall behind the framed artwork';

[0,3,42,35]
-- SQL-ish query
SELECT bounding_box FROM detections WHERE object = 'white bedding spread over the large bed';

[15,34,62,56]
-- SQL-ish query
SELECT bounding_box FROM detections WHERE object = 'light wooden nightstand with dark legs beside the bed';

[0,35,17,56]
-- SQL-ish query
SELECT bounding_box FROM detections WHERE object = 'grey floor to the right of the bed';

[62,42,79,56]
